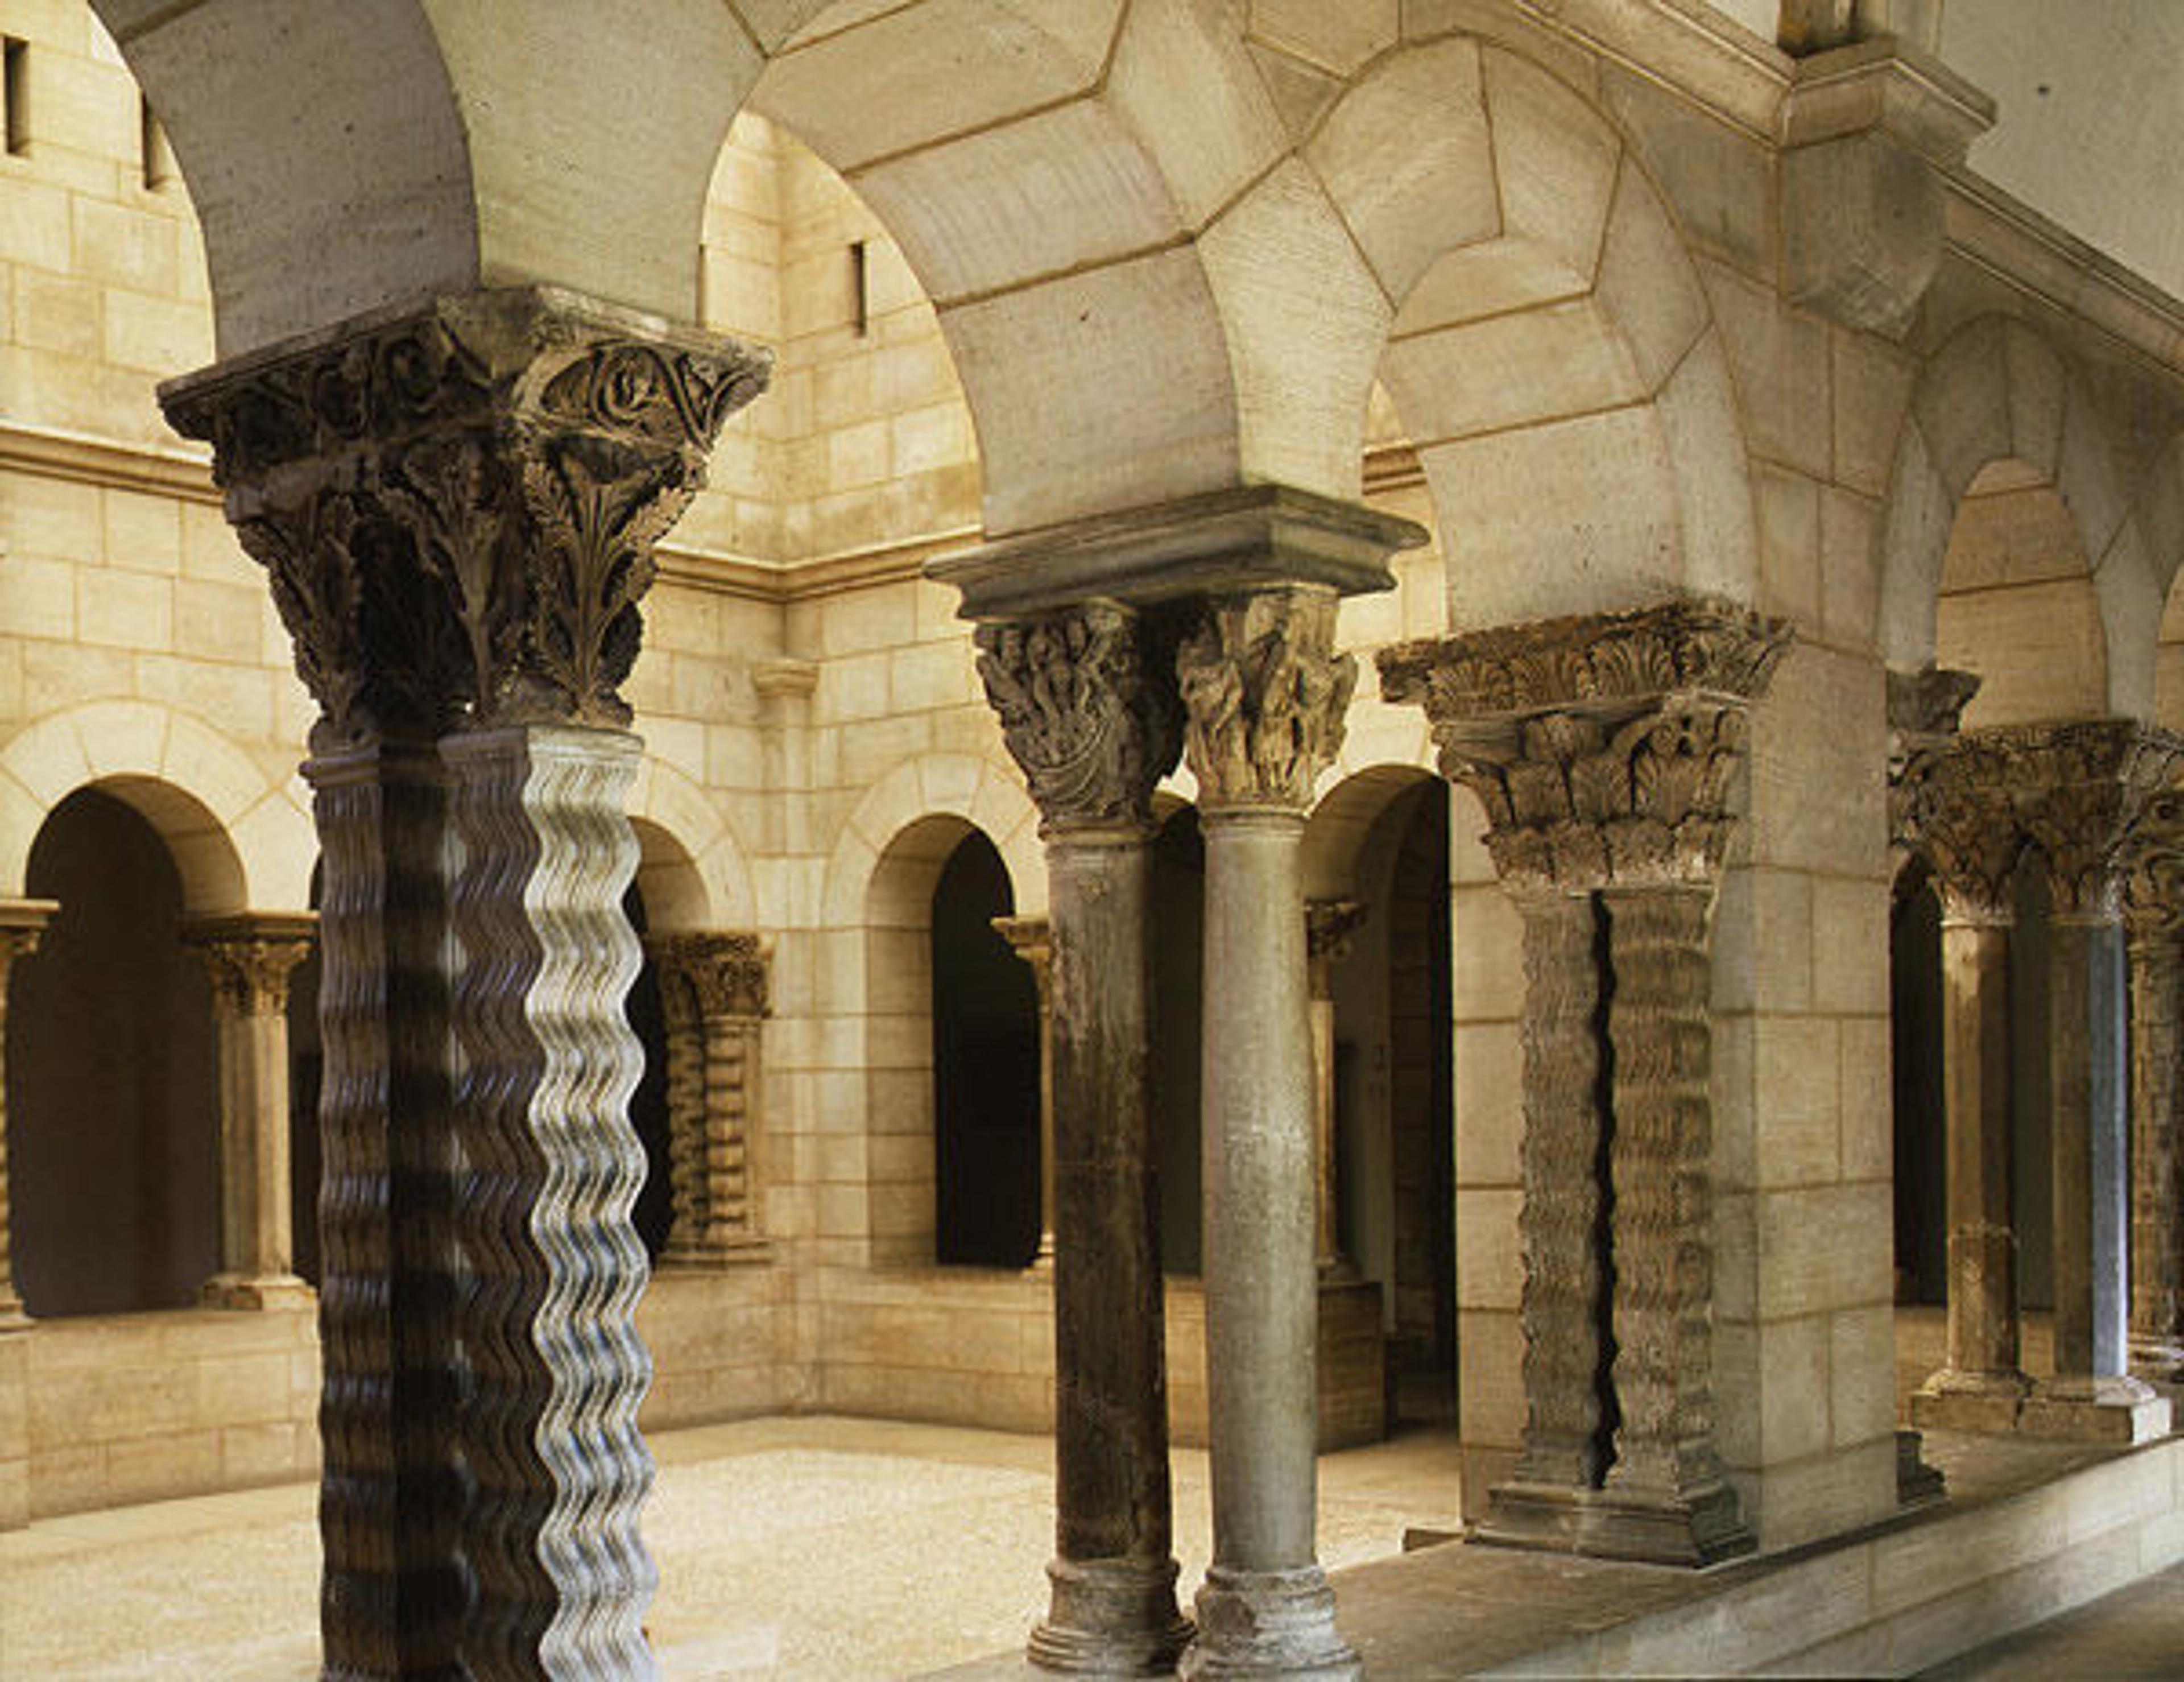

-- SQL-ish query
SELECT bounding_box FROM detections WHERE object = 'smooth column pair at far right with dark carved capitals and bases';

[1913,718,2184,1442]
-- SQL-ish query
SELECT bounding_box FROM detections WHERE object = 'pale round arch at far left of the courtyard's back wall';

[0,701,303,915]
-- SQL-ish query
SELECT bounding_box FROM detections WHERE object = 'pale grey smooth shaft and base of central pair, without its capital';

[1181,808,1360,1677]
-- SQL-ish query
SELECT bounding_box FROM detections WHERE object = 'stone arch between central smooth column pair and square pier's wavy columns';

[1302,31,1756,629]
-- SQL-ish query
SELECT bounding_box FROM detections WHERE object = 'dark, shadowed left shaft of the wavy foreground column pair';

[304,743,468,1682]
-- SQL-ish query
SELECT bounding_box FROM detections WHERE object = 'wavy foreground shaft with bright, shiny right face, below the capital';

[441,725,657,1680]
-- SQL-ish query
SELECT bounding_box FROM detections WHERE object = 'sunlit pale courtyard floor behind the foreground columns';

[0,1417,1459,1682]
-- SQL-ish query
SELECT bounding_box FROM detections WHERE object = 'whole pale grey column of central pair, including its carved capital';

[1177,585,1360,1677]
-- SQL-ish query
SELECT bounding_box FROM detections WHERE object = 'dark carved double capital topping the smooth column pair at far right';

[1926,718,2184,920]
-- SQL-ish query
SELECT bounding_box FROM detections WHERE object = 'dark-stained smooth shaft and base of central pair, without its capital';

[1031,824,1190,1675]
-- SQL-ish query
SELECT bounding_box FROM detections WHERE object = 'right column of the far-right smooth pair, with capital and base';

[2005,718,2184,1442]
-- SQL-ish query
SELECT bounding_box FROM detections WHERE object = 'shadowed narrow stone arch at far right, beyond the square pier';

[1880,315,2164,717]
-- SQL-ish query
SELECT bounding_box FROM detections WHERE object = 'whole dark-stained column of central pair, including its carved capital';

[978,603,1190,1675]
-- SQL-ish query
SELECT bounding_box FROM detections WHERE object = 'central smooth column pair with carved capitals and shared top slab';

[935,487,1413,1677]
